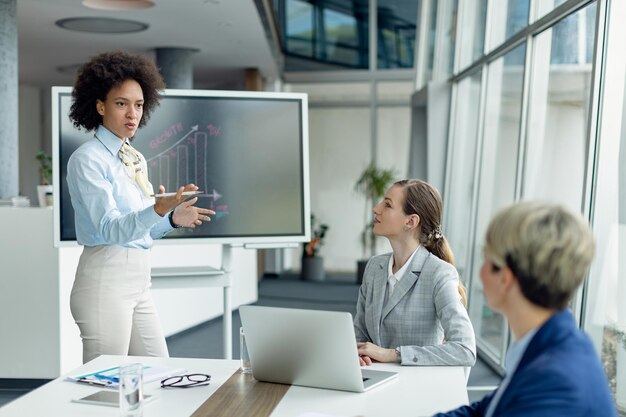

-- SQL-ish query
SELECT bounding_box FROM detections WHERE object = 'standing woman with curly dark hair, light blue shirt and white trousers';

[67,51,215,362]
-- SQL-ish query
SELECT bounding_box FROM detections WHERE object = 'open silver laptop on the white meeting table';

[239,306,398,392]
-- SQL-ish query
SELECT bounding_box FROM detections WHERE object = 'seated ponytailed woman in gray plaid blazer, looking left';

[354,180,476,366]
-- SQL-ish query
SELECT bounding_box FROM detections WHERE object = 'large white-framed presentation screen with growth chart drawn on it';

[52,87,310,246]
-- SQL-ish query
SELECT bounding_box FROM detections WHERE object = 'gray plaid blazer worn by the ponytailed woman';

[354,246,476,366]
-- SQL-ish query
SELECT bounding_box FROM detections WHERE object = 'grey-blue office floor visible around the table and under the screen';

[0,272,500,406]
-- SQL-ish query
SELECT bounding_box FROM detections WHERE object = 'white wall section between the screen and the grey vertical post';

[309,108,371,271]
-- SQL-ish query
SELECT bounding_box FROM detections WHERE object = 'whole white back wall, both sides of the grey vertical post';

[284,82,412,272]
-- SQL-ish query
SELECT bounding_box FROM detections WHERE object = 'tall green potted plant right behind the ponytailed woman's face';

[354,162,396,284]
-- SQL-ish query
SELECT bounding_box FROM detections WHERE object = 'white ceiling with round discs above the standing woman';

[17,0,278,88]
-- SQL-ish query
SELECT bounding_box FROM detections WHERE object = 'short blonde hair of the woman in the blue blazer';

[485,201,595,310]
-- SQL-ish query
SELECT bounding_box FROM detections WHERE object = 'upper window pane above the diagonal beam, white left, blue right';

[489,0,530,50]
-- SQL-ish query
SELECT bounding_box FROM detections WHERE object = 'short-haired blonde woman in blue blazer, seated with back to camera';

[437,202,617,417]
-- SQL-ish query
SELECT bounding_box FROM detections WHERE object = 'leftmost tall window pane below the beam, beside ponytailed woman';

[444,71,482,283]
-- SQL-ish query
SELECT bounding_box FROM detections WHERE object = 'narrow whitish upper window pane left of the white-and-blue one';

[459,0,487,69]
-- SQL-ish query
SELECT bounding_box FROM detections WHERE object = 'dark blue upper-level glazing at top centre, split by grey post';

[280,0,420,71]
